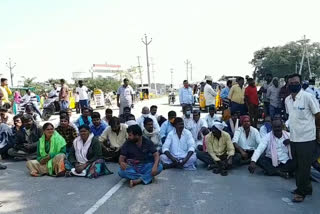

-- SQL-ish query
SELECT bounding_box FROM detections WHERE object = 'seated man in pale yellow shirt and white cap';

[197,121,239,176]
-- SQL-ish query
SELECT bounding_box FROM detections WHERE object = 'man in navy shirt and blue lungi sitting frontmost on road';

[118,125,162,187]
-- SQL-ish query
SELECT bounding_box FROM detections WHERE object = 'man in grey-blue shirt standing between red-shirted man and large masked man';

[266,77,281,120]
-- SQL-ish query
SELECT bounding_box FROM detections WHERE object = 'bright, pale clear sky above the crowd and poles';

[0,0,320,83]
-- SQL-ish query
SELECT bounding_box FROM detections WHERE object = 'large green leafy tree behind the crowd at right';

[250,40,320,80]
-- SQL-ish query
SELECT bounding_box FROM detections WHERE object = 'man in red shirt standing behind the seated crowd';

[245,78,259,128]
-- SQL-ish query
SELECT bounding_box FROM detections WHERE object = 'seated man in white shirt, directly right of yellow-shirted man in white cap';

[232,115,261,164]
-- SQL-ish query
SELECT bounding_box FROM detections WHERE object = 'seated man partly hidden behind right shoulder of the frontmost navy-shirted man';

[142,118,162,152]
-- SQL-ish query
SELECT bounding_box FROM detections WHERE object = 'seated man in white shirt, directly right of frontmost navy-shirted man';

[160,117,197,170]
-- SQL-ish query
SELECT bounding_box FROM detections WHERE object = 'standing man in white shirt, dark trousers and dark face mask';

[285,74,320,202]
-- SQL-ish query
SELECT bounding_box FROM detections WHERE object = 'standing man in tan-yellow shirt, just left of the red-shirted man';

[228,77,247,115]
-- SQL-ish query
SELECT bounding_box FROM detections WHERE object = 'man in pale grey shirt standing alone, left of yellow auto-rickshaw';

[117,78,134,115]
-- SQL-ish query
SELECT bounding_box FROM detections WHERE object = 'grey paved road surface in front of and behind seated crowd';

[0,99,320,214]
